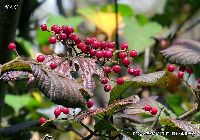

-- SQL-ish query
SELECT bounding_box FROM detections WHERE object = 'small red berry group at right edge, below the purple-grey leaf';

[167,64,200,89]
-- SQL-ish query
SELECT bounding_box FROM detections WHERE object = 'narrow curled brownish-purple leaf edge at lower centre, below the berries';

[77,95,139,121]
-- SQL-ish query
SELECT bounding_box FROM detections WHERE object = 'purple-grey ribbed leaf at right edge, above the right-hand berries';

[161,39,200,65]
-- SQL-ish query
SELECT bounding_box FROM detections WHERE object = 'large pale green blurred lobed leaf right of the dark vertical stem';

[124,17,162,53]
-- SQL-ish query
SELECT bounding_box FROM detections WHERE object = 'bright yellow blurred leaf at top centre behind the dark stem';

[77,8,122,38]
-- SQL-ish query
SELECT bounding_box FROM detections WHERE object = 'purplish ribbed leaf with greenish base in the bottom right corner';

[159,118,200,135]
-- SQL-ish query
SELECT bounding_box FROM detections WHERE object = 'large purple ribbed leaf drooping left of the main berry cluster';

[30,64,91,108]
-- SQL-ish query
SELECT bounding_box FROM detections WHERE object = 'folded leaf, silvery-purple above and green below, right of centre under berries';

[109,71,166,104]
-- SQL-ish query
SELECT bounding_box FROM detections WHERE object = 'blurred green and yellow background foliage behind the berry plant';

[1,0,200,140]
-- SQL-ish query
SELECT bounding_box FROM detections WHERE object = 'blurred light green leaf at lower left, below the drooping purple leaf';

[5,94,34,113]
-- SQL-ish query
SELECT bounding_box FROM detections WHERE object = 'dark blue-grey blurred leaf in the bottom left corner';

[0,120,38,136]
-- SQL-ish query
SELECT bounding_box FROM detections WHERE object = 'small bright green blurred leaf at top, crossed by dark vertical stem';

[101,3,133,16]
